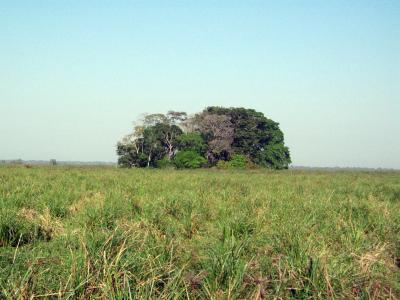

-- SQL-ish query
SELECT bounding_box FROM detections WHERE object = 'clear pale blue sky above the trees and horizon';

[0,0,400,169]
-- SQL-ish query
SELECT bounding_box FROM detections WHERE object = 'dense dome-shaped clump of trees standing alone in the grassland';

[117,106,291,169]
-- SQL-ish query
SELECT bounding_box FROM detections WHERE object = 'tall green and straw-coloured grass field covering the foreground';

[0,166,400,299]
